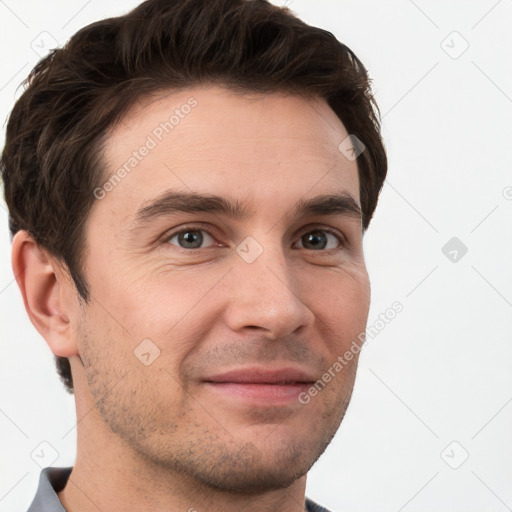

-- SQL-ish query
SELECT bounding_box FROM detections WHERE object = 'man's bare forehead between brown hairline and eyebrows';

[94,86,359,225]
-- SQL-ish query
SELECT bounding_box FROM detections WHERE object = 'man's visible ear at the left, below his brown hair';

[12,230,78,357]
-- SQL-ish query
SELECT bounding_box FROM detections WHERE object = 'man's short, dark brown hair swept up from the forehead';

[0,0,387,393]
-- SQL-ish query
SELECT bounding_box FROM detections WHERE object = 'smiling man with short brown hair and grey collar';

[1,0,386,512]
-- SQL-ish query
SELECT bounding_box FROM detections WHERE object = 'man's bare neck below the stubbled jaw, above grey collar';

[58,455,306,512]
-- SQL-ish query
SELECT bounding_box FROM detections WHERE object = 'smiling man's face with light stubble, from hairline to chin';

[73,87,370,491]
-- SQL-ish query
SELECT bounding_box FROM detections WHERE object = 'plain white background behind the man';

[0,0,512,512]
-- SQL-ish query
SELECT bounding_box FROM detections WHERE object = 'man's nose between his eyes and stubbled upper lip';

[225,240,314,339]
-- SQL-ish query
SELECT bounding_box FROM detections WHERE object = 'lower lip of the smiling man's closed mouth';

[207,382,312,405]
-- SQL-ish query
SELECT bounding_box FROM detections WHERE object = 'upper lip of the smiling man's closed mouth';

[203,366,316,384]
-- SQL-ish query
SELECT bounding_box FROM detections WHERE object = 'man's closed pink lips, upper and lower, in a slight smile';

[203,367,316,407]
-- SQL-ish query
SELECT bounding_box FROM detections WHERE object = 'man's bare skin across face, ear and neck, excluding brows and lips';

[13,86,370,512]
